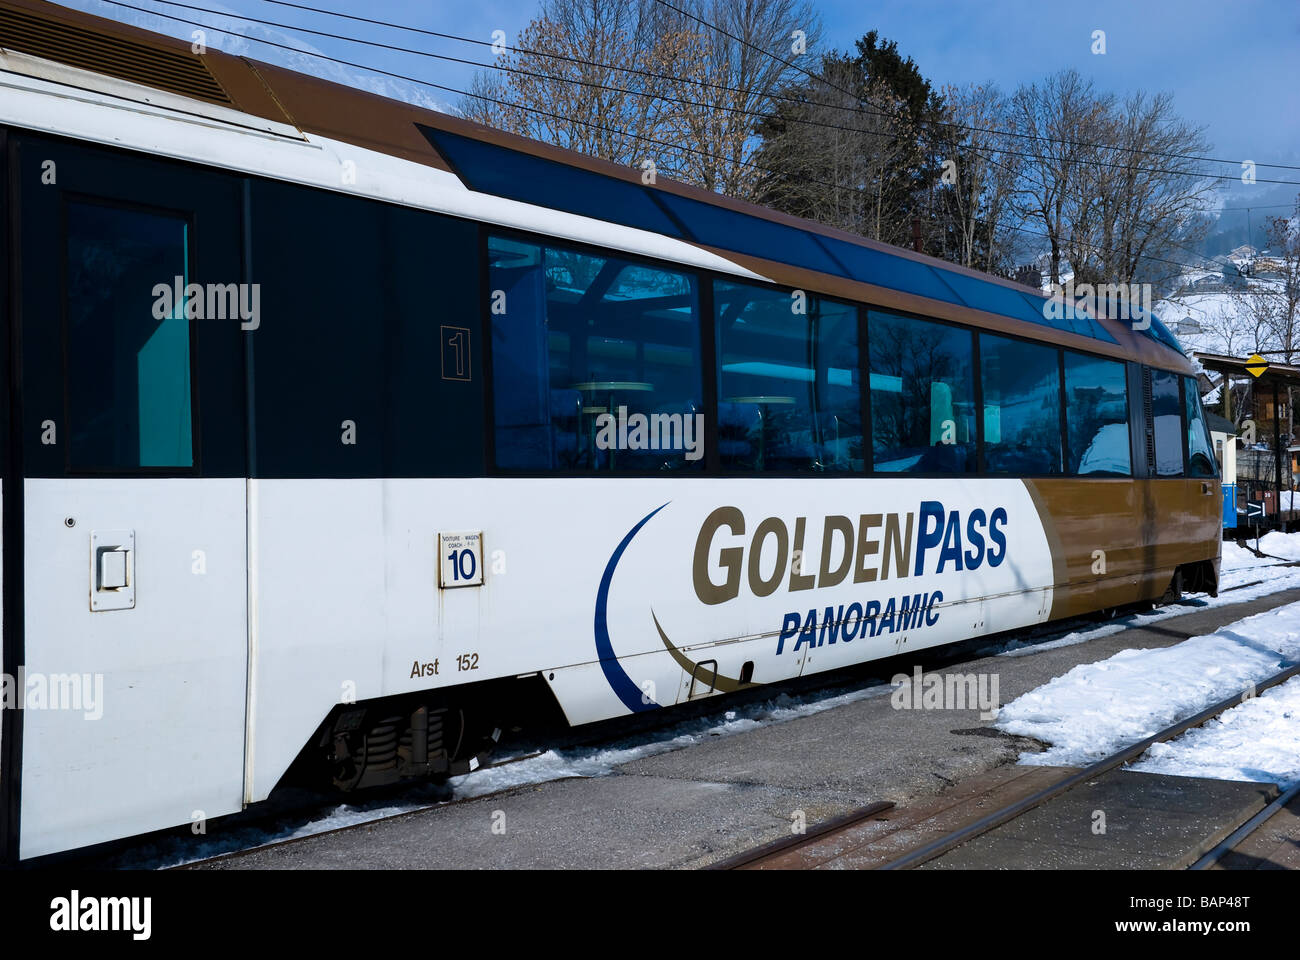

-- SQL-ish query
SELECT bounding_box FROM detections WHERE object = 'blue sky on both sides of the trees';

[55,0,1300,214]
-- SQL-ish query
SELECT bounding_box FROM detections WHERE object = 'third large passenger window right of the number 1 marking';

[867,311,975,473]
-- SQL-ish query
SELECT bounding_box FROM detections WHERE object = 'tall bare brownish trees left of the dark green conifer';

[462,0,820,198]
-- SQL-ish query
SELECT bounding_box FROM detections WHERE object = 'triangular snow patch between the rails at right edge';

[1130,676,1300,790]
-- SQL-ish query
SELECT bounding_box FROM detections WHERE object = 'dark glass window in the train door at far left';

[65,202,194,470]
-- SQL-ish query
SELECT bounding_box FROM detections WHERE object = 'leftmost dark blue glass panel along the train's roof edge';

[420,126,691,239]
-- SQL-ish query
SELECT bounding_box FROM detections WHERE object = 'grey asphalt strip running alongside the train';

[198,589,1300,869]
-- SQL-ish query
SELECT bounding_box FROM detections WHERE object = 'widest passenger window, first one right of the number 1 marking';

[489,237,703,472]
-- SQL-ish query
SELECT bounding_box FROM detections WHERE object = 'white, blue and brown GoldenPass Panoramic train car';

[0,0,1221,859]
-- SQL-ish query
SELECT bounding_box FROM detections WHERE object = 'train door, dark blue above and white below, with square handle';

[5,137,251,857]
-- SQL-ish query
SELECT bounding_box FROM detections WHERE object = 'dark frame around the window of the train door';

[59,190,203,477]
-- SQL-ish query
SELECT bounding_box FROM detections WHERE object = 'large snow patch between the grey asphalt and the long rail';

[996,604,1300,766]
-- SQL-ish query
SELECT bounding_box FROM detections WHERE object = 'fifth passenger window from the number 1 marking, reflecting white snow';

[1065,350,1132,476]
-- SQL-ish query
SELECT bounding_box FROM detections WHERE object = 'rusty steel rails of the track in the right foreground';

[710,663,1300,870]
